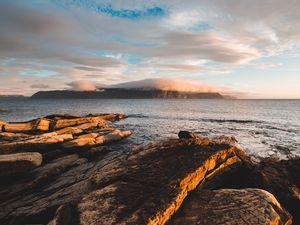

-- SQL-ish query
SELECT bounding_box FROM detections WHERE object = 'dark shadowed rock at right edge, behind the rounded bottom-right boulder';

[195,158,300,224]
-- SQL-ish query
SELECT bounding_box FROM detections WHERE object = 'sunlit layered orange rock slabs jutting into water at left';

[0,114,132,154]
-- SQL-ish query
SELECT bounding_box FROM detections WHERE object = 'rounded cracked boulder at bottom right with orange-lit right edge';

[169,188,292,225]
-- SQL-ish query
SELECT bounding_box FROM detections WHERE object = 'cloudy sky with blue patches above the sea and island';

[0,0,300,99]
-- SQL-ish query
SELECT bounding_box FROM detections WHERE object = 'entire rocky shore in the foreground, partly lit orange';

[0,114,300,225]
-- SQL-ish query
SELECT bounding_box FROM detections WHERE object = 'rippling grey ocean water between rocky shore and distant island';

[0,98,300,158]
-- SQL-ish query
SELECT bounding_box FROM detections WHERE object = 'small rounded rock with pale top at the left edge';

[0,152,43,176]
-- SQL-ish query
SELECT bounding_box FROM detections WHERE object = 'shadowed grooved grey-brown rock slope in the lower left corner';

[0,151,126,225]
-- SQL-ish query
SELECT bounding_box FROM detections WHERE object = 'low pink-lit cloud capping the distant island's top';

[110,78,223,92]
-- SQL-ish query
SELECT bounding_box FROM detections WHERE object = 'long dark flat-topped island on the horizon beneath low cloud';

[31,88,224,99]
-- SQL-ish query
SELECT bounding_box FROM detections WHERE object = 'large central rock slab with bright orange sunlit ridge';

[78,138,251,224]
